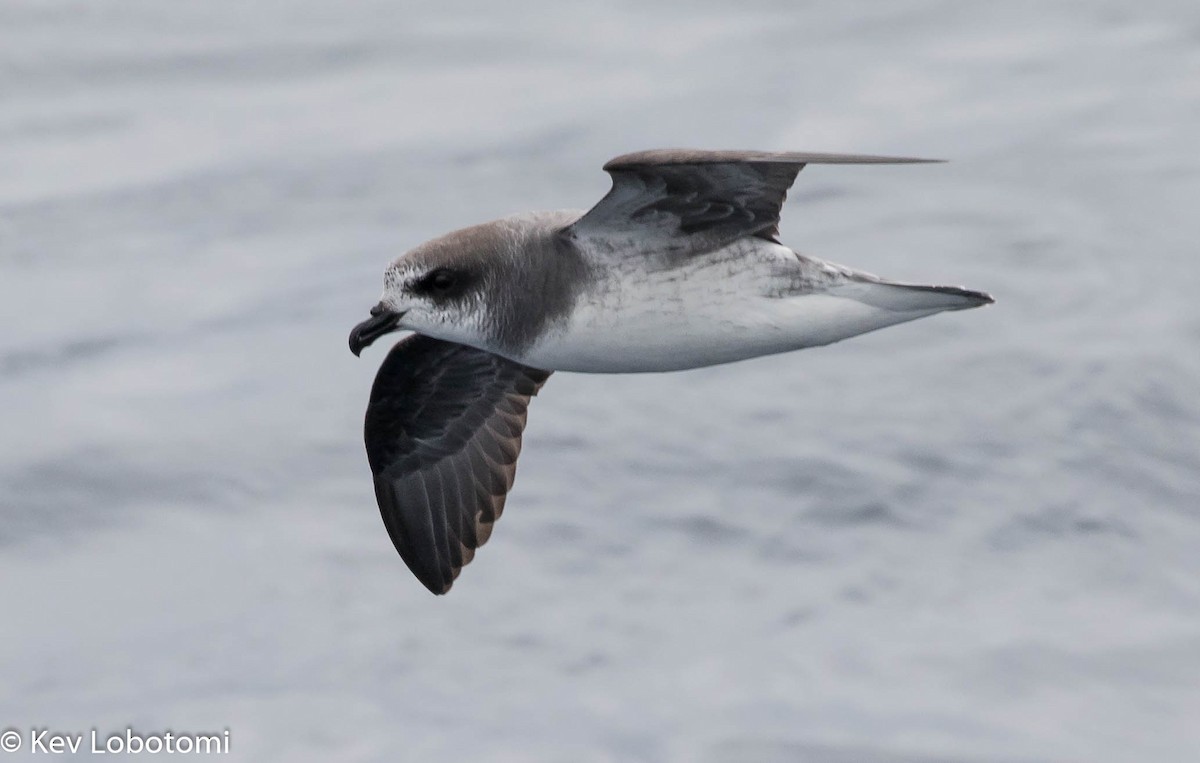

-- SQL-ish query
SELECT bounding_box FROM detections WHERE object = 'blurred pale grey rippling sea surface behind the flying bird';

[0,0,1200,763]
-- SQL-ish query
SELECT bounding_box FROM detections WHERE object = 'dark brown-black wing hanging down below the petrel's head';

[365,335,550,594]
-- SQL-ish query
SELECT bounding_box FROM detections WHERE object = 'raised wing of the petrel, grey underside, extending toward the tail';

[565,149,936,257]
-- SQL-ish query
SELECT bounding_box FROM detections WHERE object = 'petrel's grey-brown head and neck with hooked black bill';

[350,212,578,355]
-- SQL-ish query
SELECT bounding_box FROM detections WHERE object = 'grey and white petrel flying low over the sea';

[350,149,992,594]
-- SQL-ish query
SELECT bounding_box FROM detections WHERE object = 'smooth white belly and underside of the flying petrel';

[521,239,944,373]
